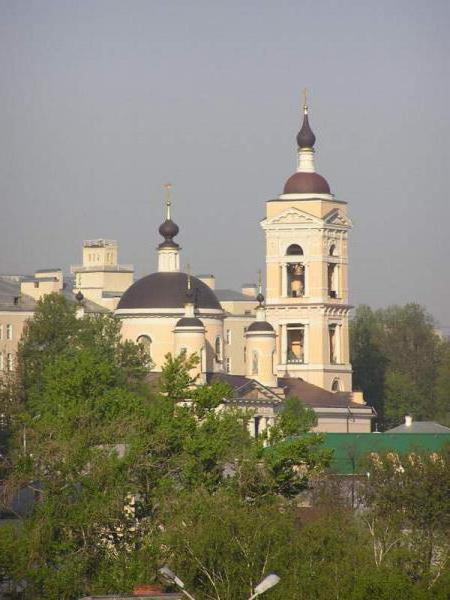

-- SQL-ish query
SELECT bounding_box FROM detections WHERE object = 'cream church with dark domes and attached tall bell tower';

[111,102,373,434]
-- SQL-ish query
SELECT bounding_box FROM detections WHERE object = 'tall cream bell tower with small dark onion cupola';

[261,93,352,392]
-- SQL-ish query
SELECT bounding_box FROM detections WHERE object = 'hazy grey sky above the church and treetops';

[0,0,450,326]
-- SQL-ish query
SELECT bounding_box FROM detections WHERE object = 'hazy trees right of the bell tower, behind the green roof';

[350,304,444,427]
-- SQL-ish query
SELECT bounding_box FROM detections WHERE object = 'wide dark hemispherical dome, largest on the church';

[117,273,222,310]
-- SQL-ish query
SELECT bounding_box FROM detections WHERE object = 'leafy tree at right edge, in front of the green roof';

[360,447,450,589]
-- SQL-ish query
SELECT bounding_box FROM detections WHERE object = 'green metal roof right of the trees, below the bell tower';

[324,433,450,475]
